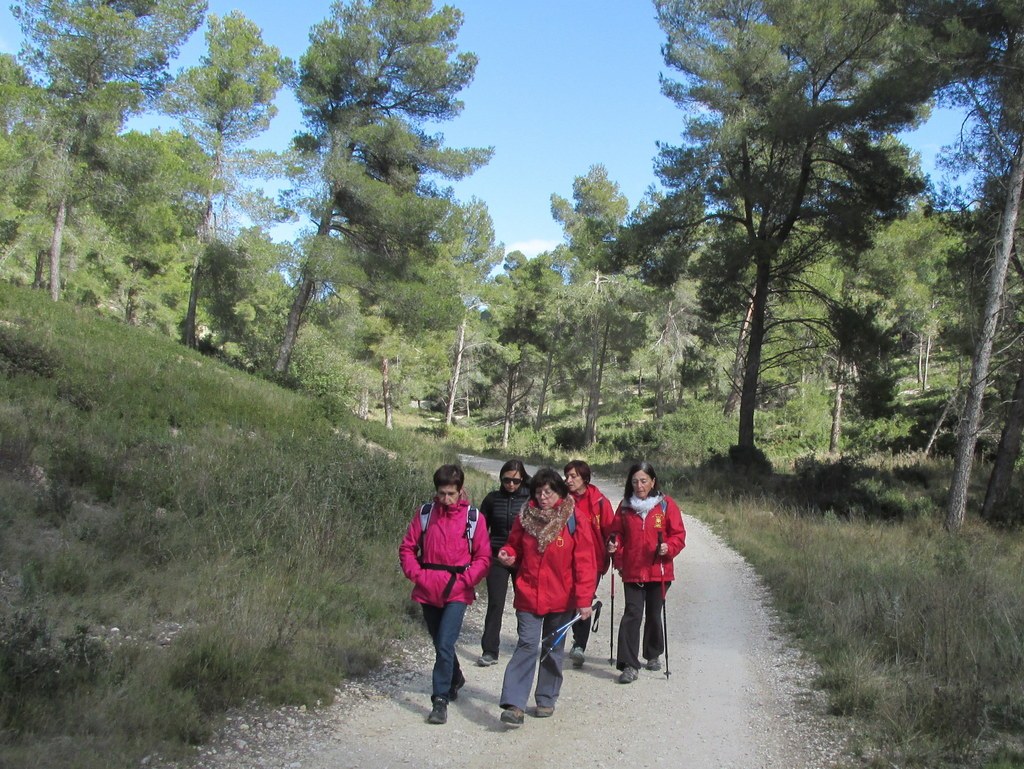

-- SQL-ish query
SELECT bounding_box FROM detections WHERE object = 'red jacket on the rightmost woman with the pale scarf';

[611,497,686,582]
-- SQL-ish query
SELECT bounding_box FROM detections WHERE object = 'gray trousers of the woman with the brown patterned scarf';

[499,611,573,710]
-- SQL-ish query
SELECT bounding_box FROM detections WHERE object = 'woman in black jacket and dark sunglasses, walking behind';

[476,460,529,668]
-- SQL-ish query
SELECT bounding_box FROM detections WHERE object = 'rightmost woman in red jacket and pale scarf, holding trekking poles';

[608,462,686,684]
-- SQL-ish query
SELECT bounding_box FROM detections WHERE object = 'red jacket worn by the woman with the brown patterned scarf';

[504,501,597,614]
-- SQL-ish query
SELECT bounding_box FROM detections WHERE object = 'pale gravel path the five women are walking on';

[176,457,844,769]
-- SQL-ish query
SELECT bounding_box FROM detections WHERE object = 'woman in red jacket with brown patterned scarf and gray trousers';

[498,467,597,726]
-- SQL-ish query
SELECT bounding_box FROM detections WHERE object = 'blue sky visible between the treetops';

[0,0,956,255]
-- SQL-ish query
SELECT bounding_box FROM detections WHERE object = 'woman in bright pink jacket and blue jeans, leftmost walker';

[398,465,490,724]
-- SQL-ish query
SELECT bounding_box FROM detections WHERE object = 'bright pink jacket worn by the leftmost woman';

[398,499,490,606]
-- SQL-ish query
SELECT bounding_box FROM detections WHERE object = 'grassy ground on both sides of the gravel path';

[0,284,1024,769]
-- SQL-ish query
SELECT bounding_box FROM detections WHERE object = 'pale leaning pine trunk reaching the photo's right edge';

[945,141,1024,531]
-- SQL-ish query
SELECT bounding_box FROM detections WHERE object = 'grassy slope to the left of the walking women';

[0,284,477,768]
